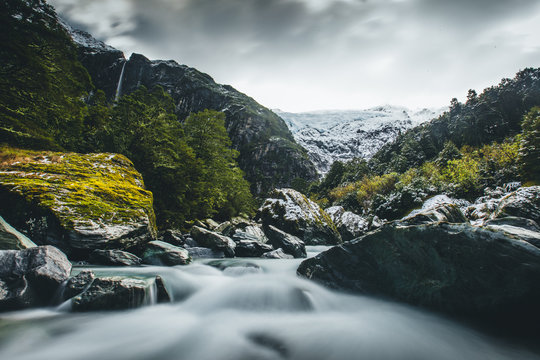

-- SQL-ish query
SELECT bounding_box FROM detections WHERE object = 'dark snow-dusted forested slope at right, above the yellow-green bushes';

[370,68,540,173]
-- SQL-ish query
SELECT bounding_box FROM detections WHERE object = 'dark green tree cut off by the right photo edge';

[519,107,540,183]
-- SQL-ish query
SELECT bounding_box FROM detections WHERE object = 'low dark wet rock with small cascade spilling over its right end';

[71,276,156,312]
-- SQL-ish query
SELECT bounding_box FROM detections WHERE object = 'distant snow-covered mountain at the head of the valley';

[274,105,445,174]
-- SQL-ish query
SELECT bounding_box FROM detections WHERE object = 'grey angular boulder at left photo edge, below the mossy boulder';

[0,245,71,310]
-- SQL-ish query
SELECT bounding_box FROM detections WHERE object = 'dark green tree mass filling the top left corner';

[0,0,92,150]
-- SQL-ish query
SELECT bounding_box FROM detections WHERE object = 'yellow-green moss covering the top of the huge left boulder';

[0,147,155,233]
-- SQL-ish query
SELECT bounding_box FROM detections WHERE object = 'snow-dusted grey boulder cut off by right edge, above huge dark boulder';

[491,186,540,224]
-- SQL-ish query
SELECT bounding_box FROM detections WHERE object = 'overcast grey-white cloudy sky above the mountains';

[48,0,540,111]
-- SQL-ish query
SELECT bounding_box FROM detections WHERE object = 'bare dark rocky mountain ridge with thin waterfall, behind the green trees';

[63,23,317,194]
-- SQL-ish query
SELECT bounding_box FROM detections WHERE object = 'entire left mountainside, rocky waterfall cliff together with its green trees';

[0,0,316,227]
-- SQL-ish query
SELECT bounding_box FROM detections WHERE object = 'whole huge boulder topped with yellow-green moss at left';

[0,147,156,256]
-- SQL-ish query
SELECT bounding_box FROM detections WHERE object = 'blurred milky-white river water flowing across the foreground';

[0,248,537,360]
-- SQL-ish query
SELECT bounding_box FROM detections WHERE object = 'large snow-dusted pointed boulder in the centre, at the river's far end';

[257,189,342,245]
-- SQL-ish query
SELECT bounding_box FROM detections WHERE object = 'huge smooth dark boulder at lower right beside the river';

[298,223,540,321]
